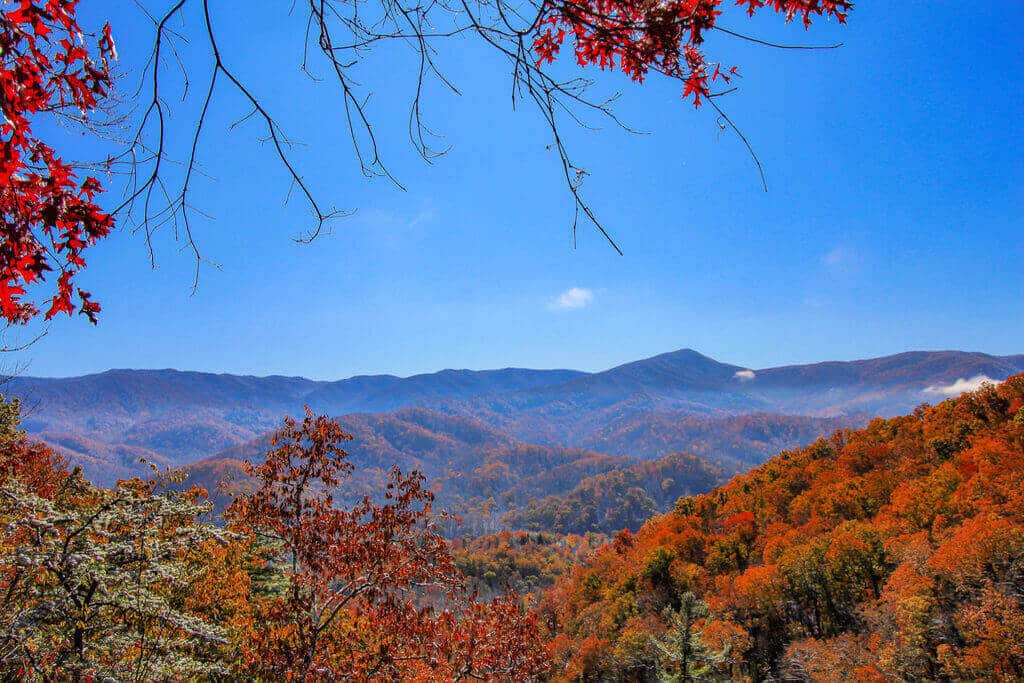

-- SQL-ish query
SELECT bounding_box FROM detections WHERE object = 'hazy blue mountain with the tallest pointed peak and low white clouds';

[443,349,1024,444]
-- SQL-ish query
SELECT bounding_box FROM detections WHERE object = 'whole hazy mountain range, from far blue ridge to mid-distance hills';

[0,349,1024,507]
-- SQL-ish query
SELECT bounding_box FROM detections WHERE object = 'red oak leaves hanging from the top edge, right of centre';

[534,0,853,106]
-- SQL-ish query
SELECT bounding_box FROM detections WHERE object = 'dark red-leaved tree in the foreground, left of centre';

[220,409,546,680]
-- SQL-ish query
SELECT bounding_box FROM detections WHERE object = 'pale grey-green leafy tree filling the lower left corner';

[0,411,227,681]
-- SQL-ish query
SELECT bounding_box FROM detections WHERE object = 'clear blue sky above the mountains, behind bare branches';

[9,0,1024,379]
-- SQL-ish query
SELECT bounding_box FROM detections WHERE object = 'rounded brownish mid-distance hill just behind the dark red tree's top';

[186,409,671,532]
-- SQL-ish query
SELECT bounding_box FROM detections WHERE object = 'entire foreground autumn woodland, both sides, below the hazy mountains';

[0,375,1024,681]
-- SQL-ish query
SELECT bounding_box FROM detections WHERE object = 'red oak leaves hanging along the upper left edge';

[0,0,115,325]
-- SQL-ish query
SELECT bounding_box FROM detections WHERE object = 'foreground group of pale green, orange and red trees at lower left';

[0,398,548,681]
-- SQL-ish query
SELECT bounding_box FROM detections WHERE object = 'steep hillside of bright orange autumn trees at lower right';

[545,375,1024,681]
